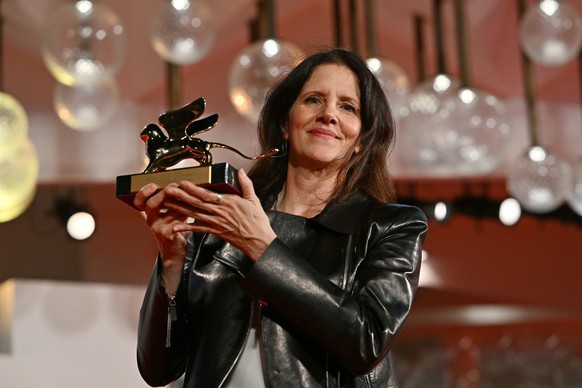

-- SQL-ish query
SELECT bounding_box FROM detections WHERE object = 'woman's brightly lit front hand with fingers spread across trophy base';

[163,169,276,261]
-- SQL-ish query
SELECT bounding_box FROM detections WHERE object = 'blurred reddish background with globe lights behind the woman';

[0,0,582,387]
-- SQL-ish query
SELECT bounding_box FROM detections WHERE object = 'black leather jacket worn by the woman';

[137,198,427,388]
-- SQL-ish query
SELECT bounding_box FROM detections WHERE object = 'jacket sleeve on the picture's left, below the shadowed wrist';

[137,239,200,386]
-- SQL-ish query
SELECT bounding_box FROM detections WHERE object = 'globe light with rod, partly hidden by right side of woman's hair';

[366,0,410,120]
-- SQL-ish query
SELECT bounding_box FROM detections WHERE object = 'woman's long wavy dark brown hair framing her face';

[249,48,396,203]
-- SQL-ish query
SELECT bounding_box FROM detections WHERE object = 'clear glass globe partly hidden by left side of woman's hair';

[229,39,304,122]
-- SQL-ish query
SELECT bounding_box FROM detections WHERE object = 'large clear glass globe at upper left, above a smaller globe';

[41,0,127,85]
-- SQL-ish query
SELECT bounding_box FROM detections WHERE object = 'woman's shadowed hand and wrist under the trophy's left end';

[134,184,188,294]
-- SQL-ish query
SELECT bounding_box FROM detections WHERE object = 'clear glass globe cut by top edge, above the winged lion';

[150,0,216,65]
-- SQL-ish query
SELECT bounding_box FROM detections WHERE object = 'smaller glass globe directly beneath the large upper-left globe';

[53,78,119,131]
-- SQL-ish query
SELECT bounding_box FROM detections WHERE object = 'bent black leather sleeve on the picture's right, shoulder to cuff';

[245,205,427,373]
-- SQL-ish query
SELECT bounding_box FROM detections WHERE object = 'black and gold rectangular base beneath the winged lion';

[115,163,241,208]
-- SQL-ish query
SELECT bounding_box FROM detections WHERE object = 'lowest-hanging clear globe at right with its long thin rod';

[507,0,570,213]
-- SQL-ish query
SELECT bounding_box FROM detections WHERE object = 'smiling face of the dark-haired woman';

[287,64,362,169]
